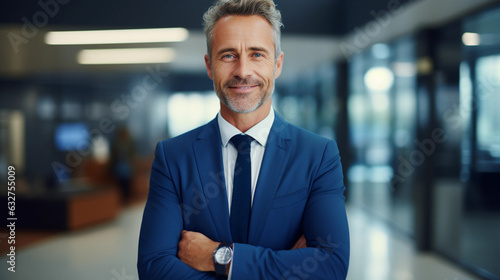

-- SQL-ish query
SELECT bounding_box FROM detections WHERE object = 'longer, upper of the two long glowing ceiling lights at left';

[45,28,189,45]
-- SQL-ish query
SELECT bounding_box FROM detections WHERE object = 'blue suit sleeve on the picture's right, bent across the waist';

[232,141,349,280]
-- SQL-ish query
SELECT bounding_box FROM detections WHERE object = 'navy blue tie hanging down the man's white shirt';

[230,134,253,243]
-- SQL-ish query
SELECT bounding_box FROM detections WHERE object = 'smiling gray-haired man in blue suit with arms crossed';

[138,0,349,280]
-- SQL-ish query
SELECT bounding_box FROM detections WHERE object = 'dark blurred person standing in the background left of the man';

[110,127,135,204]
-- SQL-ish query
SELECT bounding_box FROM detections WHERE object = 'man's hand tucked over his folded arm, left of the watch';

[177,230,220,271]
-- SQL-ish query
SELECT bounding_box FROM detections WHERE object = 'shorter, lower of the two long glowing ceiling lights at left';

[77,48,175,65]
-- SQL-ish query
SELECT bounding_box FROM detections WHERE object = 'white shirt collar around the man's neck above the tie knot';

[217,108,274,147]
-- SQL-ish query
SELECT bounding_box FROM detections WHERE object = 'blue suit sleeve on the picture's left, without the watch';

[137,143,216,280]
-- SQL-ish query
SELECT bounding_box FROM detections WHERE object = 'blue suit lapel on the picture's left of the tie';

[193,118,231,241]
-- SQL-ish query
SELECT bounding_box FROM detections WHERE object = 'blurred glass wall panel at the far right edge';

[433,6,500,279]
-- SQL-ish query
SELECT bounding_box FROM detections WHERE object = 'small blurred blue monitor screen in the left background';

[54,123,90,151]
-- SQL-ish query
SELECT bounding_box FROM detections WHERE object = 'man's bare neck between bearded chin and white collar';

[220,98,272,132]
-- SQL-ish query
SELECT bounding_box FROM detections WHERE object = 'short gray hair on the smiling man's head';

[203,0,283,58]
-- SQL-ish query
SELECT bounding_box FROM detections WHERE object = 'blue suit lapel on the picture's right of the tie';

[248,114,290,244]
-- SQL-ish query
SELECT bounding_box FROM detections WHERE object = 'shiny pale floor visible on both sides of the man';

[0,204,478,280]
